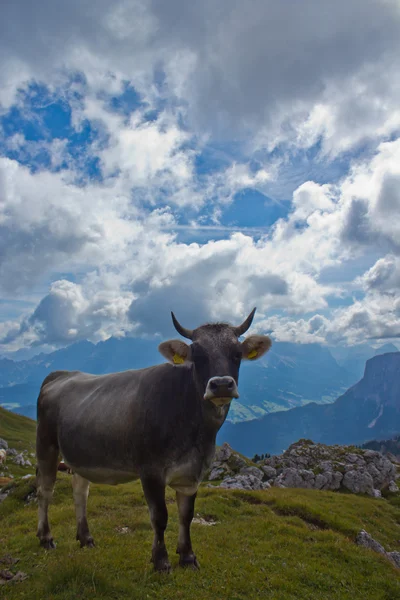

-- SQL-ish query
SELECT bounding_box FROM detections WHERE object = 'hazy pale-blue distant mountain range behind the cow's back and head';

[0,338,356,422]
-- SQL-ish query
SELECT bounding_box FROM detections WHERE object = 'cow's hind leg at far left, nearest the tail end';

[36,438,58,550]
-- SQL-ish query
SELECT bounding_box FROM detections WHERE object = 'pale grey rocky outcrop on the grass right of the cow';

[209,440,399,497]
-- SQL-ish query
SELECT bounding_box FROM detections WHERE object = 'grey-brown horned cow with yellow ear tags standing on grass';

[36,308,271,572]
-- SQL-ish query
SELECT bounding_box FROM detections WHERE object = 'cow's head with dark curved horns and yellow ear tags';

[159,308,272,406]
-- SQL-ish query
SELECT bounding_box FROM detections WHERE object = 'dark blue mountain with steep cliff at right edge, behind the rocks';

[218,352,400,456]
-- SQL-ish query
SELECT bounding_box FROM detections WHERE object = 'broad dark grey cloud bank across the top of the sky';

[0,0,400,153]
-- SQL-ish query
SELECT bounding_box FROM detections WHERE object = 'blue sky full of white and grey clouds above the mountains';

[0,0,400,356]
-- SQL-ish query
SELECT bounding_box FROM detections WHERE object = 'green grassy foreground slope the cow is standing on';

[0,474,400,600]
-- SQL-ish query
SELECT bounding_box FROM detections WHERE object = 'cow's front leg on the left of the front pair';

[141,477,171,573]
